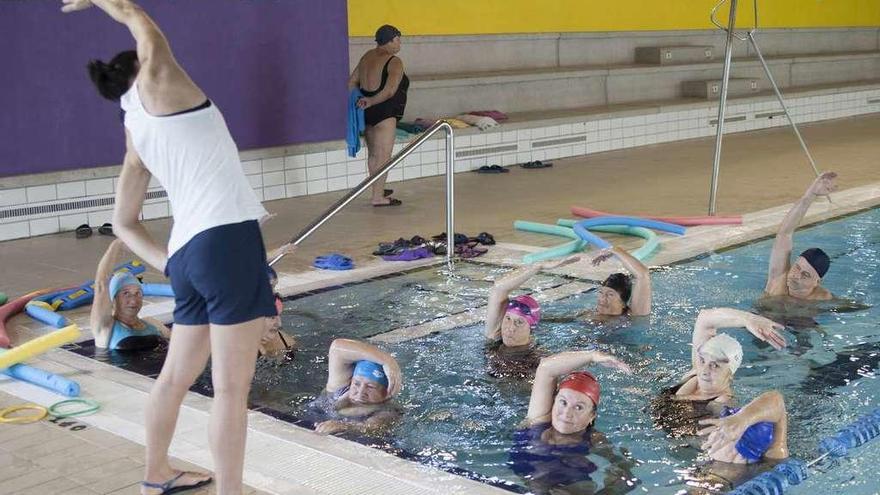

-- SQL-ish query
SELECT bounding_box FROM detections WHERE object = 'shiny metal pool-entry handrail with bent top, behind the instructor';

[269,120,455,266]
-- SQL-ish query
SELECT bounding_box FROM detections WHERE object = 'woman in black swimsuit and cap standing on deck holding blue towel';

[348,24,409,206]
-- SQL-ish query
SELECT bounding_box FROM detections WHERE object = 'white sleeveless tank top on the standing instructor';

[121,82,267,258]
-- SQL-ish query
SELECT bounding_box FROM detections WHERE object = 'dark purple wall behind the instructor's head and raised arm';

[0,0,348,177]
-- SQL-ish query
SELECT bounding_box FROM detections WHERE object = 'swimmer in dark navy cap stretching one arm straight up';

[764,172,837,301]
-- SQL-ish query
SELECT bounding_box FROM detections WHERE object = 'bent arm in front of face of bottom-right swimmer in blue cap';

[700,390,788,463]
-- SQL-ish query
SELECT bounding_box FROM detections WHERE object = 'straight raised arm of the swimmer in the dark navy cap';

[764,172,837,296]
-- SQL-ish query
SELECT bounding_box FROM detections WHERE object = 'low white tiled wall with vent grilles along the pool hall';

[0,89,880,240]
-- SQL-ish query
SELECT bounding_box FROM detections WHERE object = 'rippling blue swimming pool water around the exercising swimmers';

[67,210,880,494]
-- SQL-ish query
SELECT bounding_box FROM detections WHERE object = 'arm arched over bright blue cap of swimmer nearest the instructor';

[324,339,403,397]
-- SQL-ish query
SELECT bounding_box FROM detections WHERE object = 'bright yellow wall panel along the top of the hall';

[348,0,880,36]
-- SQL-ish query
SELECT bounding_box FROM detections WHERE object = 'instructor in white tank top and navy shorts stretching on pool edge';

[62,0,276,495]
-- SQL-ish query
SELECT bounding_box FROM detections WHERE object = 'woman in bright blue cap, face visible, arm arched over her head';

[315,339,402,434]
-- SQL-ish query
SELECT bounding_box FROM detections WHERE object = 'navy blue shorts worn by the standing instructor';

[165,220,277,325]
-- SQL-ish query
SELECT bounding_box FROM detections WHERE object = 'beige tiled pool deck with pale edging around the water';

[0,116,880,494]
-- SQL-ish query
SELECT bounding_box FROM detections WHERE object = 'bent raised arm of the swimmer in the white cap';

[691,308,785,369]
